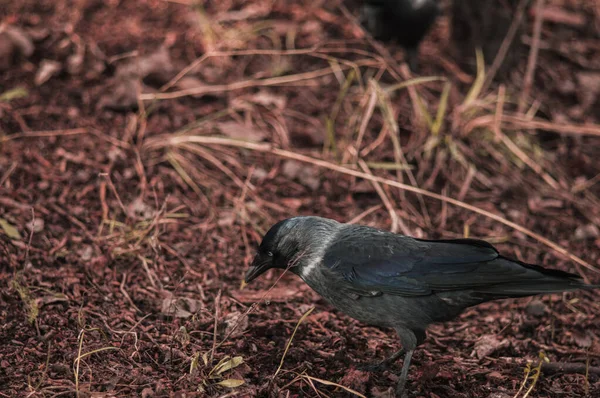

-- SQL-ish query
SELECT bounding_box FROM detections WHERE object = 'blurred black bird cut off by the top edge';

[360,0,440,71]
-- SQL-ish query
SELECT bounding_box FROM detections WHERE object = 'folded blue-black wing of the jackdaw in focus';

[323,230,576,296]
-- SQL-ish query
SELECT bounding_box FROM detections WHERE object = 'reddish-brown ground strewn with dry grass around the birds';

[0,0,600,398]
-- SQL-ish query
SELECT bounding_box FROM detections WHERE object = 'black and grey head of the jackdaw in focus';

[245,217,339,283]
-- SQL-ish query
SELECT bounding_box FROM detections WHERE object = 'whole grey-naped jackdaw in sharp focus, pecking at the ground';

[245,217,598,395]
